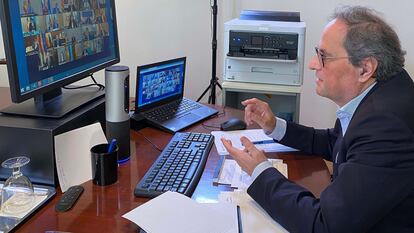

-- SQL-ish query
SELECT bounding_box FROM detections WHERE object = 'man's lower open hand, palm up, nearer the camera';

[221,137,267,176]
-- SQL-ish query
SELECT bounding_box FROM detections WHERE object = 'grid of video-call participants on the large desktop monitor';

[19,0,109,91]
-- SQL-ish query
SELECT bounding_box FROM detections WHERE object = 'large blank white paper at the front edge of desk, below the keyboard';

[122,191,238,233]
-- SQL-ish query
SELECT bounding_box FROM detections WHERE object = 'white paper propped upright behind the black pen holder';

[55,123,108,192]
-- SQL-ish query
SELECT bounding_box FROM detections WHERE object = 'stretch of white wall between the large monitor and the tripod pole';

[116,0,215,102]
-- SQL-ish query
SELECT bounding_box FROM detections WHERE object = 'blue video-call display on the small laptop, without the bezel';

[138,62,184,107]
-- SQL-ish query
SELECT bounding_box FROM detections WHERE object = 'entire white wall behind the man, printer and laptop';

[0,0,414,127]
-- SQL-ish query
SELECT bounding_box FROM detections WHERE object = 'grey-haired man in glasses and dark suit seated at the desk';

[222,7,414,233]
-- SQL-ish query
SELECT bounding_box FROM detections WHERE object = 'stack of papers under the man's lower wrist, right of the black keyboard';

[213,158,288,189]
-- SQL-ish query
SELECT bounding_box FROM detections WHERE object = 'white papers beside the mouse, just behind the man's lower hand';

[211,129,297,155]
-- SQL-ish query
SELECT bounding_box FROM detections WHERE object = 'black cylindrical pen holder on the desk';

[91,144,118,185]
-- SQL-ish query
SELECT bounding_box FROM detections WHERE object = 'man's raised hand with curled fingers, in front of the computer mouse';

[241,98,276,132]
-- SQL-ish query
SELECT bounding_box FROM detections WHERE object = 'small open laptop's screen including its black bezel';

[135,57,186,109]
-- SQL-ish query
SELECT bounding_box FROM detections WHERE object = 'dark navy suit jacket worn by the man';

[248,70,414,233]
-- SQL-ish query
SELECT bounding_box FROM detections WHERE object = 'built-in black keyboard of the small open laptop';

[143,99,201,122]
